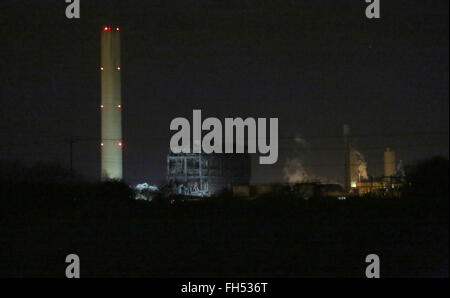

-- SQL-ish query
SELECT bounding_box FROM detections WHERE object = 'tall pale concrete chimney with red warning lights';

[100,27,123,180]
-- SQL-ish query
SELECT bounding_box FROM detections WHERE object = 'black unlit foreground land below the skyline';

[0,180,449,277]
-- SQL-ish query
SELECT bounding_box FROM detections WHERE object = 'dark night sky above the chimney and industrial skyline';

[0,0,449,183]
